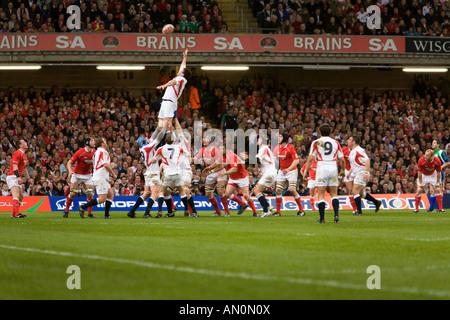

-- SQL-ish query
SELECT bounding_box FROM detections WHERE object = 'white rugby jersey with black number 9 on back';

[309,137,344,167]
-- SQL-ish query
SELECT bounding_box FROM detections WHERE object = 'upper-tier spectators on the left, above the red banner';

[0,0,228,33]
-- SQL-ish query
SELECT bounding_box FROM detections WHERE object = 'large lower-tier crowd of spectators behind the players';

[0,68,450,195]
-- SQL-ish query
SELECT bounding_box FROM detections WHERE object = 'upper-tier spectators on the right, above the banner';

[249,0,450,37]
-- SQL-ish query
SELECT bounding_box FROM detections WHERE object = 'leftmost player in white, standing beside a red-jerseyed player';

[78,138,117,219]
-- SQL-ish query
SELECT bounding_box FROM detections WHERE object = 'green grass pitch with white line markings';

[0,210,450,300]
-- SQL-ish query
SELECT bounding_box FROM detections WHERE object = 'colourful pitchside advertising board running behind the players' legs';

[0,194,442,212]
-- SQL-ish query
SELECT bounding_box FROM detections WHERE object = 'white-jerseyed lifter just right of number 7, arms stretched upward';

[175,118,198,217]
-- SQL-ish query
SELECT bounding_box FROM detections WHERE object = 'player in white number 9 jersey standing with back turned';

[303,124,345,223]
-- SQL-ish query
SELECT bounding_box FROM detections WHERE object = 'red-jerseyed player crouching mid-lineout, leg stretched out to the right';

[223,151,258,217]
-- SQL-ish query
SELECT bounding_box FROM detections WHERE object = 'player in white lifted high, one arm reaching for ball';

[156,49,191,131]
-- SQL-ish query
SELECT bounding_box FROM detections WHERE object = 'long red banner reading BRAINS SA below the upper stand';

[0,33,405,53]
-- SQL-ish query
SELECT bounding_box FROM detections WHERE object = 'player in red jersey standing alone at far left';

[6,139,30,218]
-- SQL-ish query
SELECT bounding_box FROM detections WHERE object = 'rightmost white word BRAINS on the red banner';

[294,37,352,51]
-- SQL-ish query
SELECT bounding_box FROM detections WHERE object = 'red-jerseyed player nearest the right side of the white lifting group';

[194,135,230,216]
